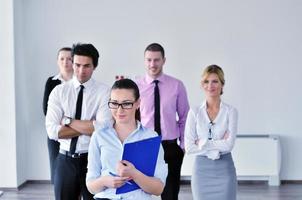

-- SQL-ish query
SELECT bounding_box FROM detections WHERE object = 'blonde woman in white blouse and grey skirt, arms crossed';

[185,65,238,200]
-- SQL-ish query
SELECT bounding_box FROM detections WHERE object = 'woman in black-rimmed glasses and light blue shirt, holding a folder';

[86,79,168,200]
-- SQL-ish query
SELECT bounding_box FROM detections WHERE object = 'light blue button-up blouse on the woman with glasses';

[86,122,167,200]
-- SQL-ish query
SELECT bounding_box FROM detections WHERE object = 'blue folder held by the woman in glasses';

[116,136,161,194]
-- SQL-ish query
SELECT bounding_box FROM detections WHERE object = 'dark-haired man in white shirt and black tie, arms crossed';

[45,44,111,200]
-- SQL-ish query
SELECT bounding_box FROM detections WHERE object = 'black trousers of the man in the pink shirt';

[161,141,184,200]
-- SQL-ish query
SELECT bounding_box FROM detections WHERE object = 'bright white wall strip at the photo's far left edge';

[0,0,17,187]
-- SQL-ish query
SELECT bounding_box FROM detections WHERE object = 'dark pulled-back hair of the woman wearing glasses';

[111,78,141,121]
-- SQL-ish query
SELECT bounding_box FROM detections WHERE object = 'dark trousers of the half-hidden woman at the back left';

[47,137,60,184]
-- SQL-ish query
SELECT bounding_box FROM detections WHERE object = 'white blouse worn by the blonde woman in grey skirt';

[185,101,238,160]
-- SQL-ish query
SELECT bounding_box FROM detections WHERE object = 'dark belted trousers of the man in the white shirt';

[54,153,93,200]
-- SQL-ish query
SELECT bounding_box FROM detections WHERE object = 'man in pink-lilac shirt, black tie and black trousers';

[137,43,189,200]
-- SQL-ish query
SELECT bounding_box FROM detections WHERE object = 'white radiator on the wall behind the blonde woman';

[181,135,281,186]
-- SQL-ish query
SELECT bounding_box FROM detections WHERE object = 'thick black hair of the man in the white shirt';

[71,43,99,68]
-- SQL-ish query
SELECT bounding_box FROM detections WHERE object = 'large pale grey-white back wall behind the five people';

[0,0,302,186]
